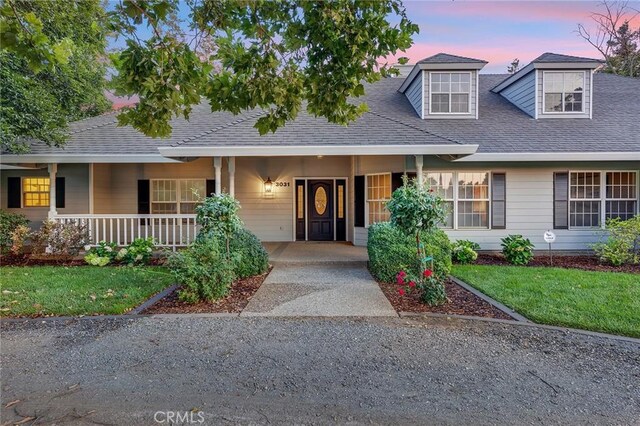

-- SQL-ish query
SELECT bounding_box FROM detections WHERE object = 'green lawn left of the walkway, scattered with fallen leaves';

[0,266,173,317]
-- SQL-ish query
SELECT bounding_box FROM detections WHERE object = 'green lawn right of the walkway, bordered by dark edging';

[452,265,640,337]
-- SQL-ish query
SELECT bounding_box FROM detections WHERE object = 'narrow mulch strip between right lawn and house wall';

[474,253,640,274]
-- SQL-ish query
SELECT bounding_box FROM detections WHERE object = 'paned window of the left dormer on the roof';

[429,72,471,114]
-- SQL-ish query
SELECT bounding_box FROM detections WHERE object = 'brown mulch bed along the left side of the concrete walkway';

[142,268,271,314]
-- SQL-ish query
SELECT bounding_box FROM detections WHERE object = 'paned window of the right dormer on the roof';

[542,71,585,113]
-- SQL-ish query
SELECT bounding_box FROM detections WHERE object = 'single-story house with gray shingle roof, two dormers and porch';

[1,53,640,250]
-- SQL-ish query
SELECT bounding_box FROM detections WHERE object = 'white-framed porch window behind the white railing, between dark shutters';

[151,179,206,214]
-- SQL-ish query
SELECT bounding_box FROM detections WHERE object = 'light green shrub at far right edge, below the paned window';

[593,216,640,266]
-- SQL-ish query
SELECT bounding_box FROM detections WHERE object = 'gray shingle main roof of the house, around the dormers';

[3,73,640,155]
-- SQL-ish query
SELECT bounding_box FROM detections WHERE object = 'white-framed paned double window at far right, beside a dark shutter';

[556,171,638,228]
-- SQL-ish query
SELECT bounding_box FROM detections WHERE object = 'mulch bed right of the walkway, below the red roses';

[378,280,513,320]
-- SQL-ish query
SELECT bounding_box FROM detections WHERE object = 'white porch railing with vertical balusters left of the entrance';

[53,214,200,249]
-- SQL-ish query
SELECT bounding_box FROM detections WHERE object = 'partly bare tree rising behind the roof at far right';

[578,0,640,77]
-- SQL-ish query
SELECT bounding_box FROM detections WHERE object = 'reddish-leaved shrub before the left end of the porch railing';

[31,220,89,256]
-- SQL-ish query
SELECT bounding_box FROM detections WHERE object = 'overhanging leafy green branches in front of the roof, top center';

[110,0,418,136]
